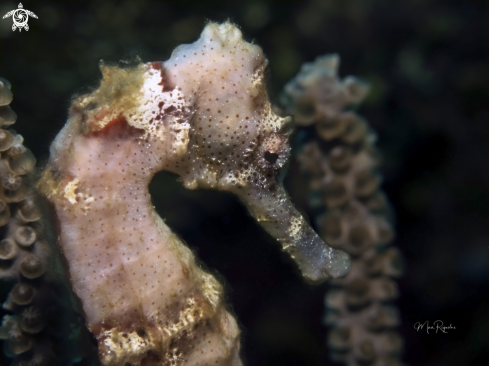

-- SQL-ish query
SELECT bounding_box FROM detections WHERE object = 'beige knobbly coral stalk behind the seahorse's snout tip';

[285,55,402,366]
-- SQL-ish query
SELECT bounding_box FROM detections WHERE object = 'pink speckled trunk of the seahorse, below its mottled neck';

[42,108,240,365]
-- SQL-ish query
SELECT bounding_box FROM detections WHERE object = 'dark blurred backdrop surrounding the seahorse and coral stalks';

[0,0,489,366]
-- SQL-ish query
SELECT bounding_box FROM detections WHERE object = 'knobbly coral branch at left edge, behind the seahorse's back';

[0,78,96,365]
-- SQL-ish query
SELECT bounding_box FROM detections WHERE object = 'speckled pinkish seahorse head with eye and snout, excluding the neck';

[161,23,350,280]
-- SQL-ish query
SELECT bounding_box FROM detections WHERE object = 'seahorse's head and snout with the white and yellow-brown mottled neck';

[48,22,349,280]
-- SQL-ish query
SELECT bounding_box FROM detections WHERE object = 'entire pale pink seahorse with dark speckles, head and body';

[41,23,349,365]
